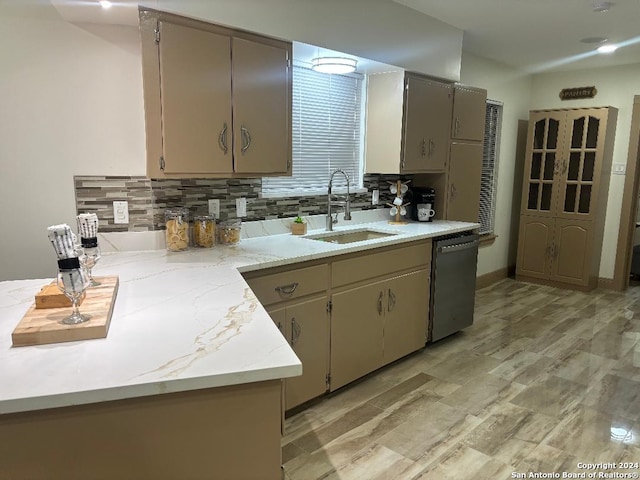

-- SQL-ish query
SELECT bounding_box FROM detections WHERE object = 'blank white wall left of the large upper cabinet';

[0,2,145,280]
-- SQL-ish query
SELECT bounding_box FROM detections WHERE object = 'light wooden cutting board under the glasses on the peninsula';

[11,275,118,347]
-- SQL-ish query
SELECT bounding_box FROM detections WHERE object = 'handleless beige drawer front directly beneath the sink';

[331,240,431,287]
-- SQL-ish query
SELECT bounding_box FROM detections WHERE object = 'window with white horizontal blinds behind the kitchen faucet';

[262,66,364,196]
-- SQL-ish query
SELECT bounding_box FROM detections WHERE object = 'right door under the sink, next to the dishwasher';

[383,269,431,364]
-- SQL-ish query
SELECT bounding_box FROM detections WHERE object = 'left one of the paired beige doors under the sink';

[331,281,387,391]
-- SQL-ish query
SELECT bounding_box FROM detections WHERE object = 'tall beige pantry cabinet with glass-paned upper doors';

[516,107,618,290]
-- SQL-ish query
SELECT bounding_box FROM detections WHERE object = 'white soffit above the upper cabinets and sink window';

[155,0,463,80]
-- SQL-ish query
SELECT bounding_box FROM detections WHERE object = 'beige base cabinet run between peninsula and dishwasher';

[245,240,432,410]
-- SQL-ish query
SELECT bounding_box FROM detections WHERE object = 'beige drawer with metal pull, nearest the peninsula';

[247,265,329,305]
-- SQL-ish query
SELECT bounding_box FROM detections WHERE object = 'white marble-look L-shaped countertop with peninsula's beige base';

[0,211,477,479]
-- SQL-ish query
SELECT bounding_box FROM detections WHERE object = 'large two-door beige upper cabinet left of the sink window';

[140,10,291,178]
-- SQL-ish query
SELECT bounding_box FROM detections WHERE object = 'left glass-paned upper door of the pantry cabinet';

[522,112,566,216]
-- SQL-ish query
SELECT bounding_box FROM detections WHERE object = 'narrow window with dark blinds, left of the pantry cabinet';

[478,100,502,235]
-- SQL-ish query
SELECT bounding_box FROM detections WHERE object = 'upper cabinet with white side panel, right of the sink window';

[365,71,453,174]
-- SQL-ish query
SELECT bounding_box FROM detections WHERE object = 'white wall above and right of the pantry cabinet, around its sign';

[531,64,640,278]
